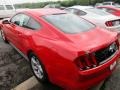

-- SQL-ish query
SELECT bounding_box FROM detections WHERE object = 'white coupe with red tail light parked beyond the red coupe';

[65,5,120,32]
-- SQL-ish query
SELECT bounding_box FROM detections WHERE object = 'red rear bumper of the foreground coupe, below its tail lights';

[64,51,120,90]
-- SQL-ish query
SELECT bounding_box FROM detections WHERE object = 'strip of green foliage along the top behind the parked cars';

[15,0,120,8]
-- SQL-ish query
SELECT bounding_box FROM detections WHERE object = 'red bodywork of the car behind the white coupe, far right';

[97,6,120,16]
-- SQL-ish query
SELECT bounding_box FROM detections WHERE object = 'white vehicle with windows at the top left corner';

[0,5,16,19]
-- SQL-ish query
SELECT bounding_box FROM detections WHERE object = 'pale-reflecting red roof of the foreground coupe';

[24,8,66,16]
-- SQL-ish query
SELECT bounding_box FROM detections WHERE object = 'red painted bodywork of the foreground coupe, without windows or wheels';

[1,9,120,90]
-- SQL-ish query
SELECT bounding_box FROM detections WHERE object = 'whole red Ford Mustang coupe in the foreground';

[0,9,120,90]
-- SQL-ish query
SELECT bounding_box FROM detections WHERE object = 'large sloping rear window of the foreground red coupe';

[43,14,95,34]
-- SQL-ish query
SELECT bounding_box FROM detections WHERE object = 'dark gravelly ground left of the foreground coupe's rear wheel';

[0,34,32,90]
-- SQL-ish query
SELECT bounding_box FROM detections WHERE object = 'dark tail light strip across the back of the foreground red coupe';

[74,40,119,71]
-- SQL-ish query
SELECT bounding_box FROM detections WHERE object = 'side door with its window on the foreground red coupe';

[5,13,30,50]
